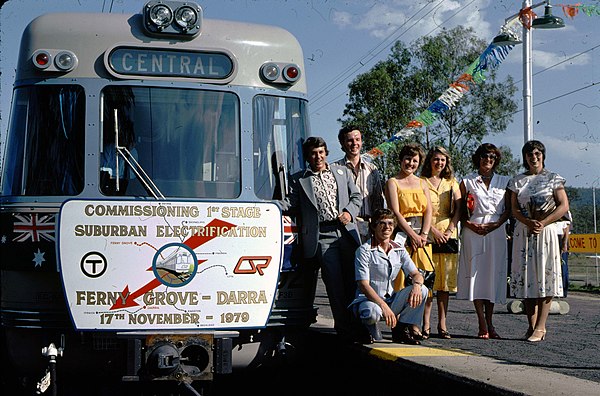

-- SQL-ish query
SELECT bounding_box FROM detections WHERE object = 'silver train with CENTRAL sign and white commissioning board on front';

[0,0,318,395]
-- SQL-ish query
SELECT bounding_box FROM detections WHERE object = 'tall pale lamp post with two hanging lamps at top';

[492,0,565,142]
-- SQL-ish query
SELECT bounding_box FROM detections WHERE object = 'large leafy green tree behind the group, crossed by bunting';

[338,26,519,176]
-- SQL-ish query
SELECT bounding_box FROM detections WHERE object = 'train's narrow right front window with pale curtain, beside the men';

[253,95,310,200]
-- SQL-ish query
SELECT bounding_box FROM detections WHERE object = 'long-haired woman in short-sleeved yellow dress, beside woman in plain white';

[421,146,462,339]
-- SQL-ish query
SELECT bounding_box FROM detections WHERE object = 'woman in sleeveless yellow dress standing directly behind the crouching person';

[386,143,434,338]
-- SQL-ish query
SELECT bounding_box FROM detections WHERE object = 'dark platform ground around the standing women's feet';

[315,272,600,383]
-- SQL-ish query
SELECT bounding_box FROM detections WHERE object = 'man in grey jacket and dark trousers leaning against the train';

[278,137,361,340]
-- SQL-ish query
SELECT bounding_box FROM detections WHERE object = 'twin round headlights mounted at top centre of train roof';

[142,0,202,38]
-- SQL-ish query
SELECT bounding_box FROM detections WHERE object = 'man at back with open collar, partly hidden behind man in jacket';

[334,125,385,243]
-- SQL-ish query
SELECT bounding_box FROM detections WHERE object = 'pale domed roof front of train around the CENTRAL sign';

[16,13,306,93]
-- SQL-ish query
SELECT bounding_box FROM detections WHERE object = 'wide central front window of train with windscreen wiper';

[100,86,241,198]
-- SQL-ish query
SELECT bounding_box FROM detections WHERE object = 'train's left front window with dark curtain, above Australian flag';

[2,85,85,196]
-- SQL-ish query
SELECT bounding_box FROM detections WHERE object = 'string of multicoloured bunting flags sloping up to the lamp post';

[367,3,600,158]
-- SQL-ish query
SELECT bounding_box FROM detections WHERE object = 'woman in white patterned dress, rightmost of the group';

[508,140,569,342]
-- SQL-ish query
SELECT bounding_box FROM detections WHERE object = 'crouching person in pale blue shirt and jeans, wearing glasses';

[351,209,428,345]
